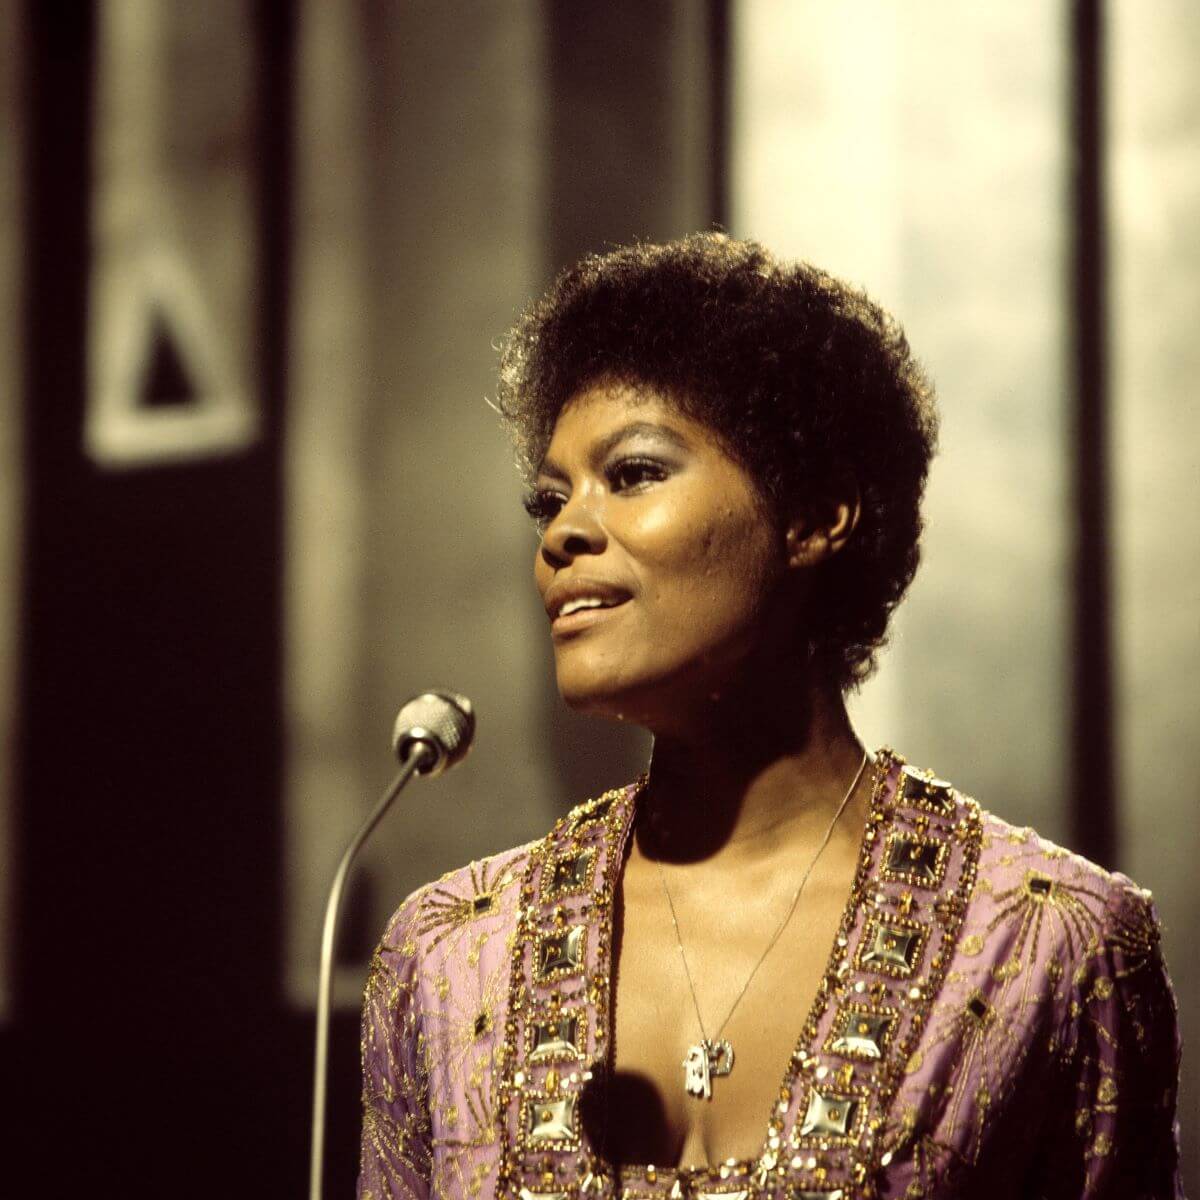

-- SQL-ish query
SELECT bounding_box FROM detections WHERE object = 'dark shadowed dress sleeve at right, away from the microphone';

[1033,876,1183,1200]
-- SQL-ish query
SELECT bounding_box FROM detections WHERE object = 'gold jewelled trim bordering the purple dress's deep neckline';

[498,749,979,1200]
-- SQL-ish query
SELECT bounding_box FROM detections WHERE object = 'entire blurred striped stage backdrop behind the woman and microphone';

[0,0,1200,1200]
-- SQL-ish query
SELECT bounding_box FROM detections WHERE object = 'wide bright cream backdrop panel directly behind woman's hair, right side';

[731,0,1069,840]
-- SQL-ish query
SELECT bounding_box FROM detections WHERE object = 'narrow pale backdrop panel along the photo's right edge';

[1106,0,1200,1171]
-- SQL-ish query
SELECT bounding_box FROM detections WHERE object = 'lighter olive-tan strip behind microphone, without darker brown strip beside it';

[288,0,554,1006]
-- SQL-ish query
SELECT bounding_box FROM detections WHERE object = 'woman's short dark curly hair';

[496,233,937,691]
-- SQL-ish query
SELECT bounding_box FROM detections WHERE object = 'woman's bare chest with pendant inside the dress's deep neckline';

[601,863,853,1165]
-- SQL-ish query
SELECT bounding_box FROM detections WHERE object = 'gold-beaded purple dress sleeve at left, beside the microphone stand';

[358,894,431,1200]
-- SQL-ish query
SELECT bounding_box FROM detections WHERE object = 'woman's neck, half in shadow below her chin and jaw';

[635,689,870,865]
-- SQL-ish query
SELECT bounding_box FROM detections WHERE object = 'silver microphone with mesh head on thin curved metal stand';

[308,691,475,1200]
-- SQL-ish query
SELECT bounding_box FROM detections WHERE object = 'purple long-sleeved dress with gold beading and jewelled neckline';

[358,751,1183,1200]
